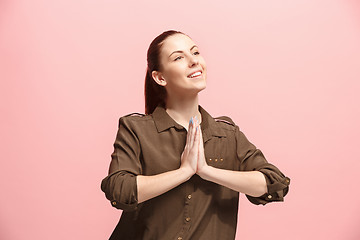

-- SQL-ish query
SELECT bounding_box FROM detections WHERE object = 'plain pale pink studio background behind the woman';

[0,0,360,240]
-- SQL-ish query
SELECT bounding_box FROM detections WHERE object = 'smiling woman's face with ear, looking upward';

[153,34,206,95]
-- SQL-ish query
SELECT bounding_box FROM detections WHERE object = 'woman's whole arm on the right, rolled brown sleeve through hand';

[196,116,290,202]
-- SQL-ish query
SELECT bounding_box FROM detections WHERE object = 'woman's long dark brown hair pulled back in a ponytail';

[144,30,186,114]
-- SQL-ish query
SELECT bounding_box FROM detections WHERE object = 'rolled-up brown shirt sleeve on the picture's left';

[101,117,142,211]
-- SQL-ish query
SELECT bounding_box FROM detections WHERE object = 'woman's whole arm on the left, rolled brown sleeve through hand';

[101,117,199,211]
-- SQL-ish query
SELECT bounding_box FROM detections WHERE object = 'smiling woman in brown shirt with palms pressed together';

[101,30,290,240]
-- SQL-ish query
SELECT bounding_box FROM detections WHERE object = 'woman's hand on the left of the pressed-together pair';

[180,118,200,178]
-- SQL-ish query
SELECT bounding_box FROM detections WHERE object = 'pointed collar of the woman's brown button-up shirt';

[150,105,226,142]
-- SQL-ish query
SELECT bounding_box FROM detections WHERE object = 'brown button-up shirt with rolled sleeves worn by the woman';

[101,105,290,240]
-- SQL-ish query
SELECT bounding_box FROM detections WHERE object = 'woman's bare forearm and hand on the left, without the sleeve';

[136,117,201,203]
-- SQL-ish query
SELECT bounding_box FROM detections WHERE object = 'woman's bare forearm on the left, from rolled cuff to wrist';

[136,168,193,203]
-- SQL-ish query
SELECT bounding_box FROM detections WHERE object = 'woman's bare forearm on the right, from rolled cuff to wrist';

[198,166,267,197]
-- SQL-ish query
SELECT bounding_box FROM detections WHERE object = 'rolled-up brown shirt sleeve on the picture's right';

[235,126,290,205]
